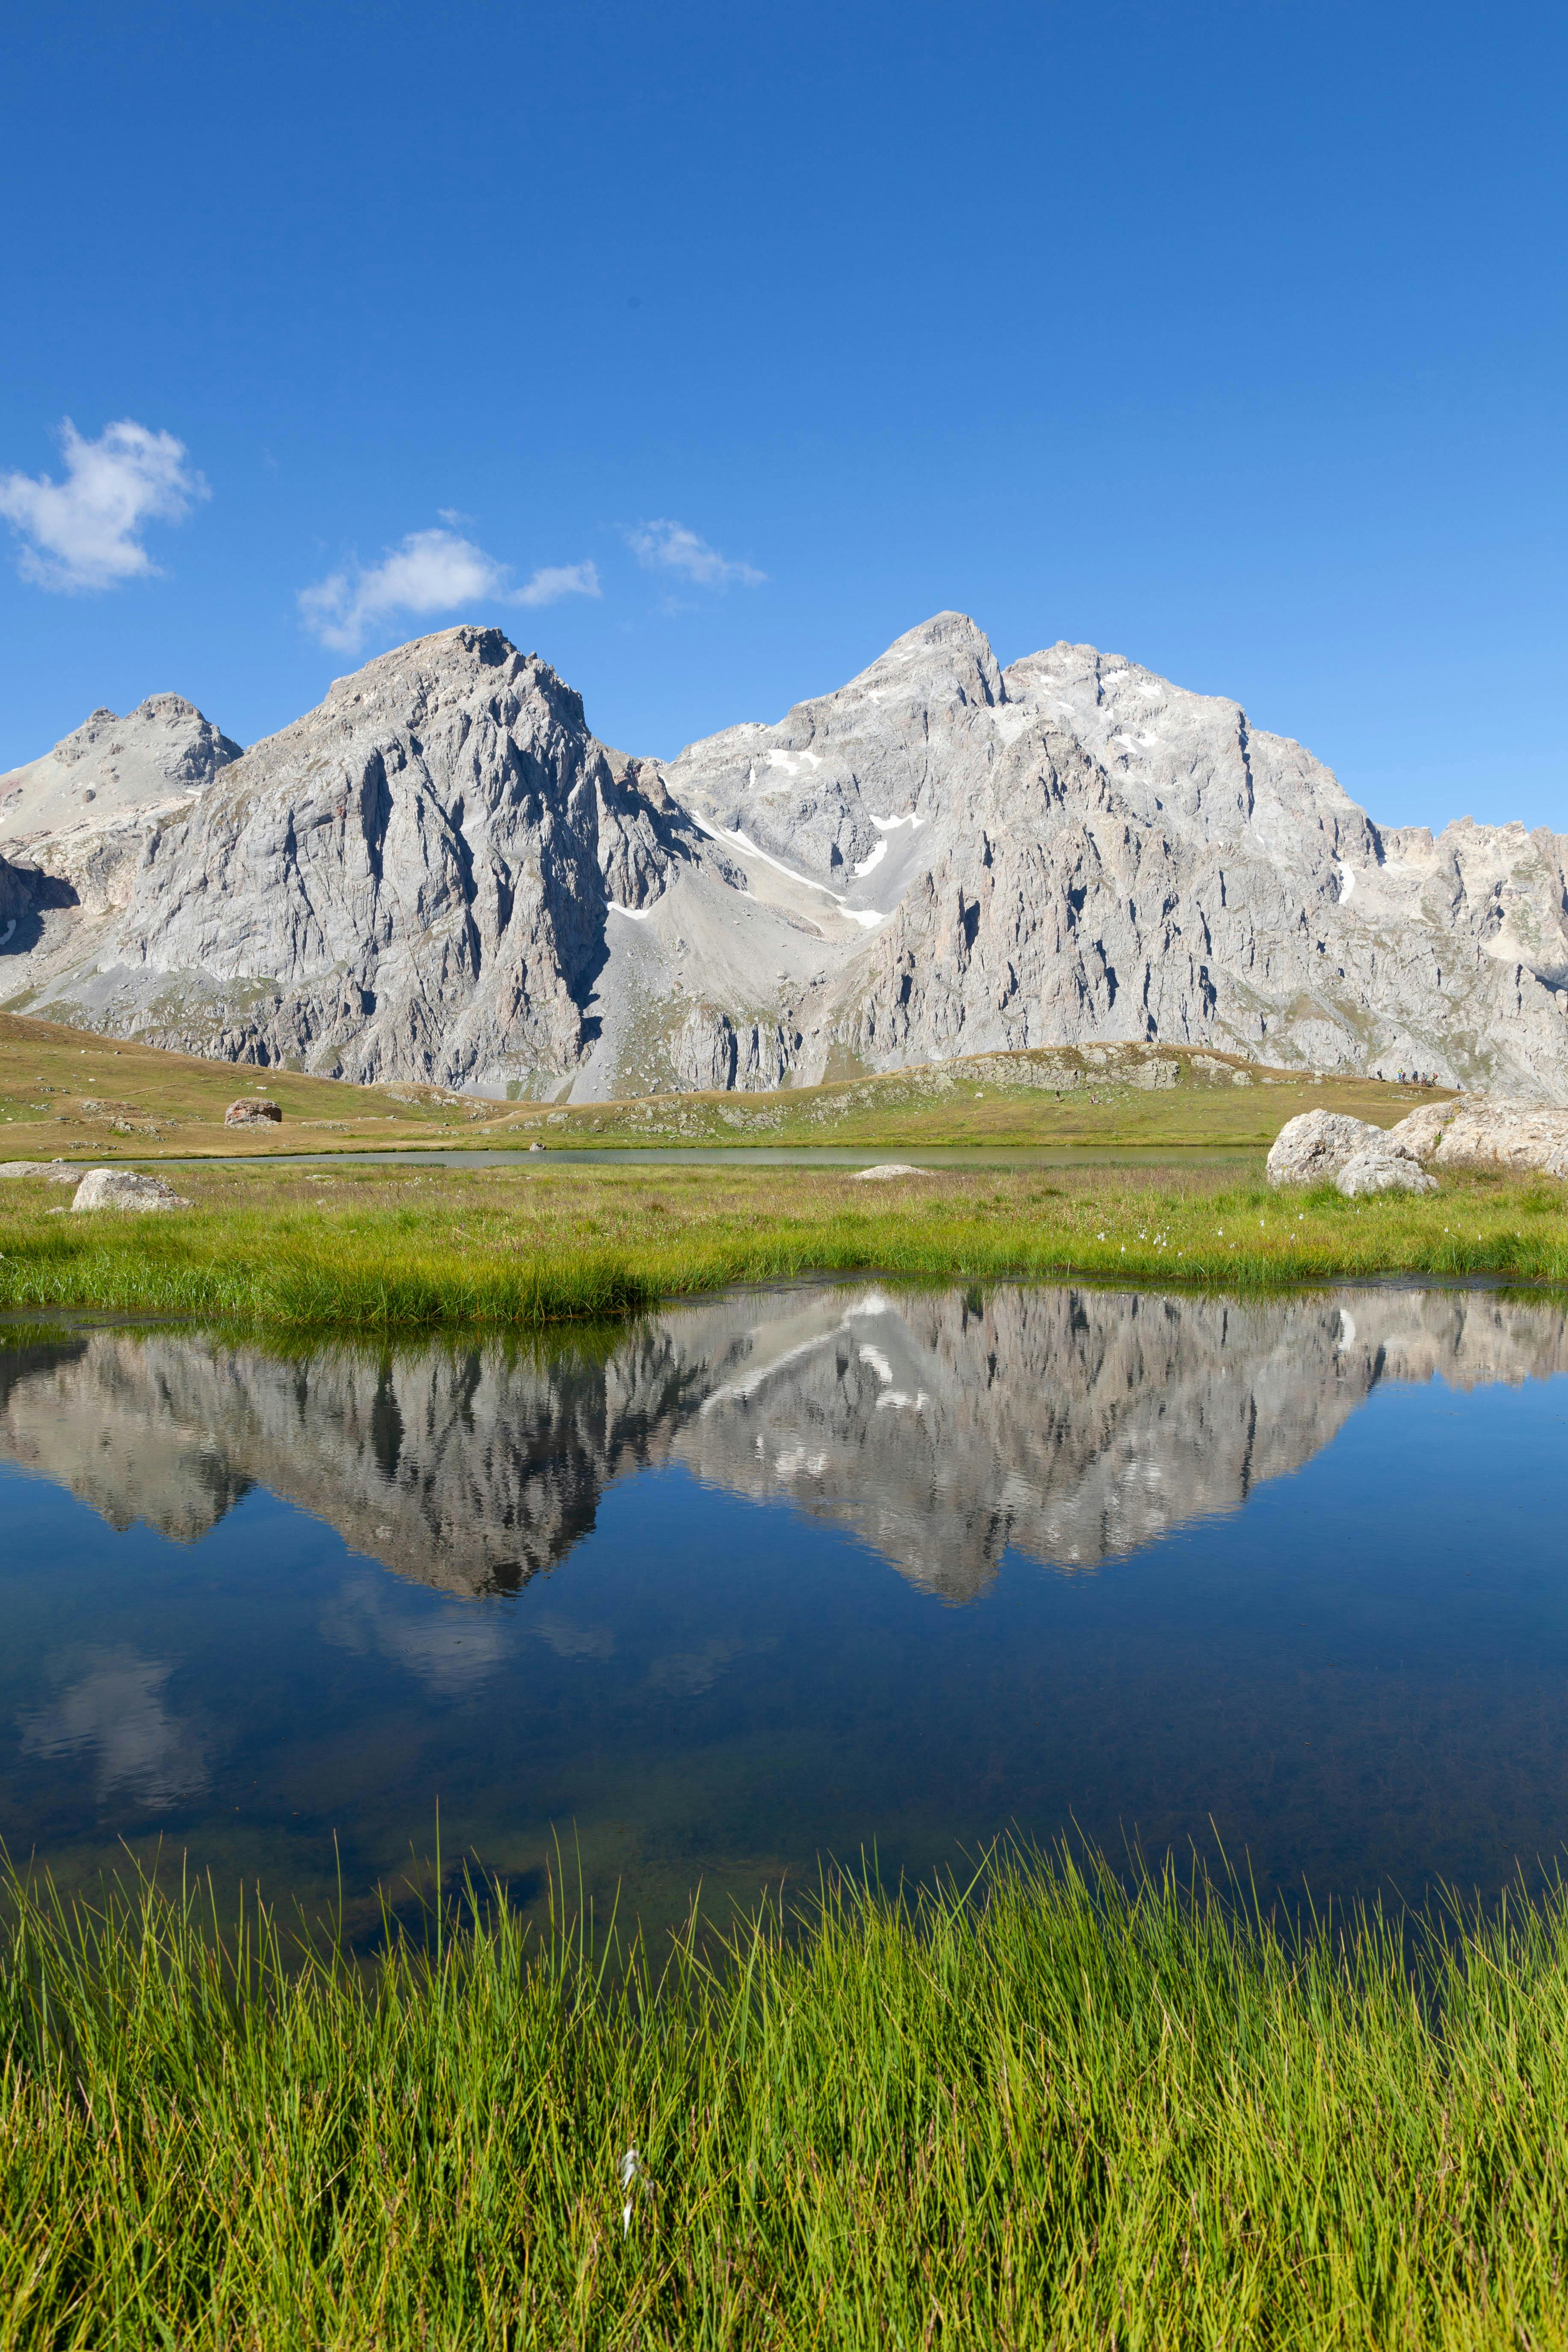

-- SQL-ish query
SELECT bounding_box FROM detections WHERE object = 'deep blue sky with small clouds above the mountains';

[0,0,1568,830]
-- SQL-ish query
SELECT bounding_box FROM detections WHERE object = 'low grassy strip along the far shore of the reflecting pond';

[0,1160,1568,1331]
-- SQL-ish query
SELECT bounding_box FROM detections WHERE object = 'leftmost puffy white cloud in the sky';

[0,416,209,590]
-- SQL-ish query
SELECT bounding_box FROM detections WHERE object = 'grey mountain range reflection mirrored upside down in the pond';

[0,1287,1568,1608]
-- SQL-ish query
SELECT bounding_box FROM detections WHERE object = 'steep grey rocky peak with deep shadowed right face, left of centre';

[4,628,729,1084]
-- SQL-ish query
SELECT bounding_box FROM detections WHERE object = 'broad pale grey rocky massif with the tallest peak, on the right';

[667,614,1568,1101]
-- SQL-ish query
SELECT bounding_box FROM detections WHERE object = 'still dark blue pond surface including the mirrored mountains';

[0,1284,1568,1933]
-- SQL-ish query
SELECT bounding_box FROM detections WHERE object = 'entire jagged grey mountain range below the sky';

[0,611,1568,1103]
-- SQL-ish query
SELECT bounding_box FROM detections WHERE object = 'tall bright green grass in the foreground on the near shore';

[0,1865,1568,2352]
